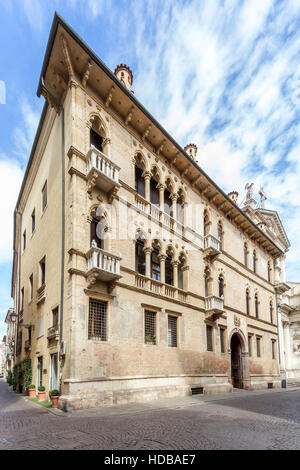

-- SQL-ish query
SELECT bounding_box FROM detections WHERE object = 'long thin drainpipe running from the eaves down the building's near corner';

[41,77,65,395]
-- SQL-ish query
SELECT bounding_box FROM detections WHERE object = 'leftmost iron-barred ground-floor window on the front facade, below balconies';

[88,299,107,341]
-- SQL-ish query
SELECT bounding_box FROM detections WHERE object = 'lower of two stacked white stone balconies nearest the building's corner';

[86,246,122,286]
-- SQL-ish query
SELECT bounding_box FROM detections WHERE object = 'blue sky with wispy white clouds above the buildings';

[0,0,300,339]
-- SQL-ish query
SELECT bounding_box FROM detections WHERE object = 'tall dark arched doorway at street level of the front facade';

[230,328,250,390]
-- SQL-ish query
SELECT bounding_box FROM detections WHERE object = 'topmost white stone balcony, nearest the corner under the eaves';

[87,145,120,193]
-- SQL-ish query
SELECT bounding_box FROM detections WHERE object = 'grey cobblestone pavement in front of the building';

[0,379,300,450]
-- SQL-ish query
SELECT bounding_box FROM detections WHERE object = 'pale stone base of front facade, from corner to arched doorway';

[58,375,232,411]
